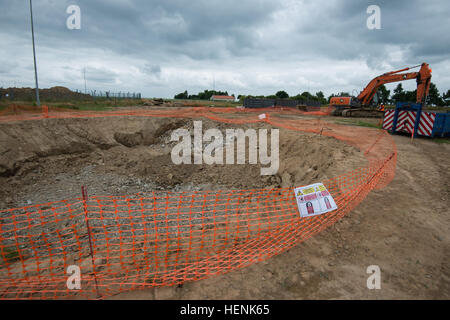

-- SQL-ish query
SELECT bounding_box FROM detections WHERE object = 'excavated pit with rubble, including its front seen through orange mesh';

[0,117,366,298]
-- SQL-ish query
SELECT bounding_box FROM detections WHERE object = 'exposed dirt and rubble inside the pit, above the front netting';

[0,117,366,208]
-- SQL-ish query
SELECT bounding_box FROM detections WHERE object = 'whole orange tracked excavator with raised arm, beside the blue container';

[330,63,432,118]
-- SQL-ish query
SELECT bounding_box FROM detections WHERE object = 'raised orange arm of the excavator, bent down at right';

[358,63,432,106]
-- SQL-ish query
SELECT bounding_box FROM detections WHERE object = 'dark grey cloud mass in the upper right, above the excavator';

[268,0,450,63]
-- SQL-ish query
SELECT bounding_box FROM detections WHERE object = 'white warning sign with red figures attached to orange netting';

[294,183,337,218]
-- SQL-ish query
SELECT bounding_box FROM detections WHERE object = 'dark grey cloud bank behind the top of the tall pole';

[0,0,277,59]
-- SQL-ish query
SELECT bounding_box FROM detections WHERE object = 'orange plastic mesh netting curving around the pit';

[0,107,397,299]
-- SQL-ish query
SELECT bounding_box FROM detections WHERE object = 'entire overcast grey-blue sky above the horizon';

[0,0,450,98]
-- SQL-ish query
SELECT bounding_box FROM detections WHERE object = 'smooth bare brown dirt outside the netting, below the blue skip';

[112,131,450,299]
